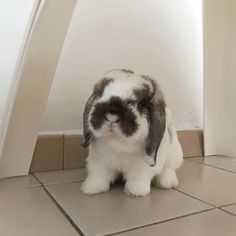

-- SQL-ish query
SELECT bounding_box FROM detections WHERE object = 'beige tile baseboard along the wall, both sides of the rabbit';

[30,130,203,172]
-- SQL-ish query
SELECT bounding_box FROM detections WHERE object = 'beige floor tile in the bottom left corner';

[0,187,78,236]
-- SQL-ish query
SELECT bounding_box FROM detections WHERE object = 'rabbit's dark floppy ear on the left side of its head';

[82,78,113,147]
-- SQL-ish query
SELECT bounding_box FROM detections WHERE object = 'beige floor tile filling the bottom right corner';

[117,210,236,236]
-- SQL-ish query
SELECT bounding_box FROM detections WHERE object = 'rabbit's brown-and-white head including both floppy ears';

[83,70,166,164]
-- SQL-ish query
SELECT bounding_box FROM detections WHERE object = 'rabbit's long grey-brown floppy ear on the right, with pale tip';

[142,77,166,166]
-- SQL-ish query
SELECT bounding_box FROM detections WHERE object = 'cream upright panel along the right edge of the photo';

[204,0,236,157]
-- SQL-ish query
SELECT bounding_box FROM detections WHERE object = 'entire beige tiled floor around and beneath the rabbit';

[0,157,236,236]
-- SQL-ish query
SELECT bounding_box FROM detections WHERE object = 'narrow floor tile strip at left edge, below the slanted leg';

[0,175,40,188]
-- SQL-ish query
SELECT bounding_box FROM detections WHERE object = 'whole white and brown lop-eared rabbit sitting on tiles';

[81,69,183,196]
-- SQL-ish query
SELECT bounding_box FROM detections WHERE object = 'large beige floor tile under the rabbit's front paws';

[47,182,210,235]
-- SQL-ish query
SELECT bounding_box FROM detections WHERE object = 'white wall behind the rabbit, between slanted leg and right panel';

[41,0,203,131]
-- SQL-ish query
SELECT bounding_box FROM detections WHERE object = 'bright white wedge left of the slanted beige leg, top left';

[0,0,35,144]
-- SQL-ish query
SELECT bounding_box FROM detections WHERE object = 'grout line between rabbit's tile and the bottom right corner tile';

[104,208,214,236]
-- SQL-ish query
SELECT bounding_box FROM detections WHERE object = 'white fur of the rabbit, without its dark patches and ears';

[82,72,183,196]
